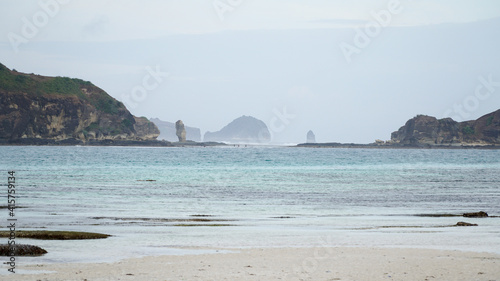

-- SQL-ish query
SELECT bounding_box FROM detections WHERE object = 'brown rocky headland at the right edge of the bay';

[391,110,500,146]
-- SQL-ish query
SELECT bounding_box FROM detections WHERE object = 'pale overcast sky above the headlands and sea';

[0,0,500,143]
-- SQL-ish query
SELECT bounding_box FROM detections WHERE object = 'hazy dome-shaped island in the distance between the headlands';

[203,116,271,143]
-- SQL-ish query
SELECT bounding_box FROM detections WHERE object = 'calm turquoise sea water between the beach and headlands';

[0,146,500,262]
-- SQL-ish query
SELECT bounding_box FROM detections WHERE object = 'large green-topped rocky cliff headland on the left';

[0,64,159,142]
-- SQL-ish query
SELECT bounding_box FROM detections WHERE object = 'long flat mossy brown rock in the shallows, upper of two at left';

[0,230,111,240]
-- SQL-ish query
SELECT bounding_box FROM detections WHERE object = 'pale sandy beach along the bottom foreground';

[4,247,500,281]
